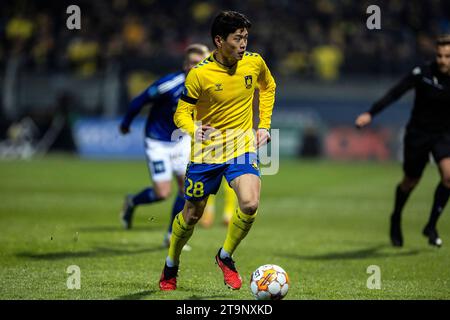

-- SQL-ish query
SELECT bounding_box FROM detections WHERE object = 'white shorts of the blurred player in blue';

[145,135,191,182]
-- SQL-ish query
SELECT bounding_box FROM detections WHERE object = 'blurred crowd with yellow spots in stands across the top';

[0,0,450,81]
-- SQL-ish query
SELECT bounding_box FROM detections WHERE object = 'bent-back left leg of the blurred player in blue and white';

[121,138,172,229]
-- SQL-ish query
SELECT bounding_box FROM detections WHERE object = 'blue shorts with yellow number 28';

[184,153,261,201]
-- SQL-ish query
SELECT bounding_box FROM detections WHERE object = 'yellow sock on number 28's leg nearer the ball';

[223,207,257,255]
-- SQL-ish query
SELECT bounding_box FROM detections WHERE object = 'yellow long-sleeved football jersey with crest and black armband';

[174,52,276,163]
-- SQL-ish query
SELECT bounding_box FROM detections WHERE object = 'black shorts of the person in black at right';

[403,127,450,178]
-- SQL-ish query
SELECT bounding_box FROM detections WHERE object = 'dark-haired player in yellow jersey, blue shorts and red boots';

[159,11,275,290]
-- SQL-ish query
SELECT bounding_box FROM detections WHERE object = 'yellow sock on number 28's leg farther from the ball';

[168,212,194,265]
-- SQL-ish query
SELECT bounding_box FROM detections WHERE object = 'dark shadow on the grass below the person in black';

[283,245,420,261]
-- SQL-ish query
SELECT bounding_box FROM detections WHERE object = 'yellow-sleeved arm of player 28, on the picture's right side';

[256,58,276,148]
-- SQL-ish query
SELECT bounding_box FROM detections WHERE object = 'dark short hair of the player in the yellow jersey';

[211,11,252,45]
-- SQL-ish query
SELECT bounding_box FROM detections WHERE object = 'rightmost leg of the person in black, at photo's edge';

[423,135,450,247]
